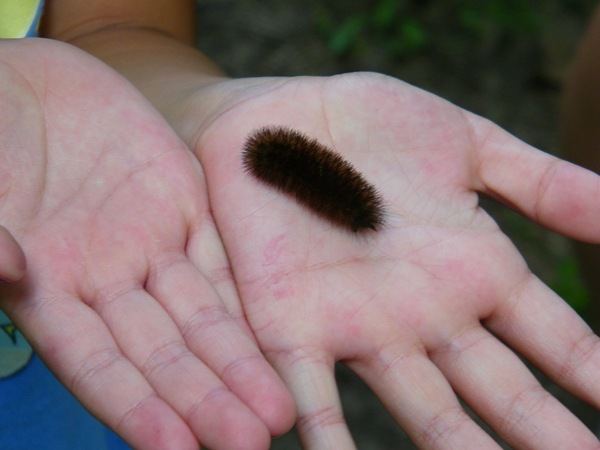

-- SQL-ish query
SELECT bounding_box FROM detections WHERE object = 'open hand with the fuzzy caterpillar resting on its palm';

[185,74,600,450]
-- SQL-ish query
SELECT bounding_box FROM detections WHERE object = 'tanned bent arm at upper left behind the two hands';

[42,0,224,137]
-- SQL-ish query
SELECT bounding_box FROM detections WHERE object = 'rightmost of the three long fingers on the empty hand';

[146,260,294,435]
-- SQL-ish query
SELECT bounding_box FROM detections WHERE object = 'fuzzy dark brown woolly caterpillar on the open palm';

[242,127,385,233]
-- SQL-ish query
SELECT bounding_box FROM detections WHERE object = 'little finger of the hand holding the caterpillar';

[271,352,355,450]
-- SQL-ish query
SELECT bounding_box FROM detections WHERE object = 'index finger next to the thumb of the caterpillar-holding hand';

[485,275,600,409]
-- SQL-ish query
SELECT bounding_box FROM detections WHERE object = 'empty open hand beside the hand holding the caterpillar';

[0,40,293,449]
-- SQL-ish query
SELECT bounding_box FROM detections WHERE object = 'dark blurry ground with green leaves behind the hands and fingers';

[198,0,600,450]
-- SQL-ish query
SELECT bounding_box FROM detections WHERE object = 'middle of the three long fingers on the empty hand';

[93,286,270,448]
